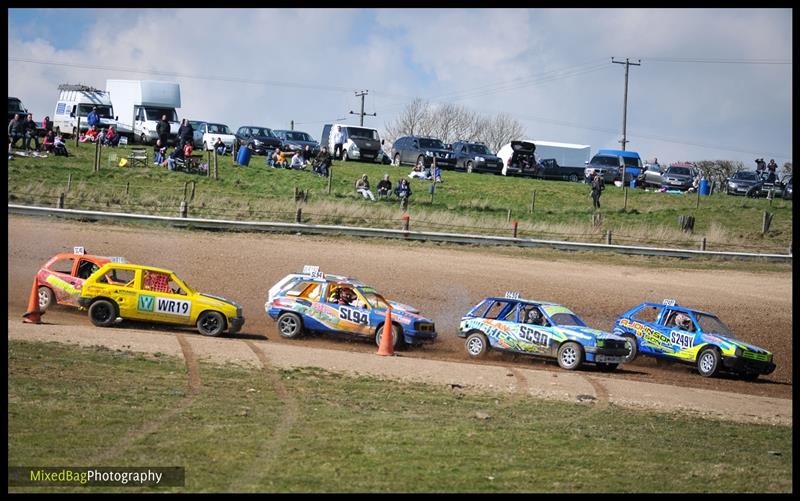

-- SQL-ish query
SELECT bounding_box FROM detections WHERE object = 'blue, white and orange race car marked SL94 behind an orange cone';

[264,266,436,347]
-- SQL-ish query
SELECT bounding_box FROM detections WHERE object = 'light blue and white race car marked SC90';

[458,293,628,371]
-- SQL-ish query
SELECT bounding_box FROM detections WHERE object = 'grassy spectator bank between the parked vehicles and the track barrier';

[8,144,792,253]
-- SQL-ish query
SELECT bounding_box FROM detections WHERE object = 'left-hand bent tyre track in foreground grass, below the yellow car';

[88,333,203,464]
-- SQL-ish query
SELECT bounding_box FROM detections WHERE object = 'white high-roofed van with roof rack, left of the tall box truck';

[53,84,117,136]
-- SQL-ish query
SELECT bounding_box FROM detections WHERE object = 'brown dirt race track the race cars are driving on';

[8,216,792,398]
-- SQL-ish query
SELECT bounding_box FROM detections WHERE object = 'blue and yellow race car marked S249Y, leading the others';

[614,299,775,380]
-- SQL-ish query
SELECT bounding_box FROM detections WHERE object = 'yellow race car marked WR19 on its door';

[78,263,244,336]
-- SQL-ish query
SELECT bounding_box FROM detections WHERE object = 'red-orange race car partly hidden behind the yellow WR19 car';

[36,247,125,311]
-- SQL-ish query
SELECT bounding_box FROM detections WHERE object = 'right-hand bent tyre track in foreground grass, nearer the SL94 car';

[230,339,300,490]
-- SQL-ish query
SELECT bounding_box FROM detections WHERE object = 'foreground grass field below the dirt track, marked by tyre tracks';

[8,341,792,493]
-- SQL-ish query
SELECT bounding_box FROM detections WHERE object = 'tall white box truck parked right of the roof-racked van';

[106,80,181,144]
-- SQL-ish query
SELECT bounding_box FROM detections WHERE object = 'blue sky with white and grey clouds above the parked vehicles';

[8,8,792,169]
